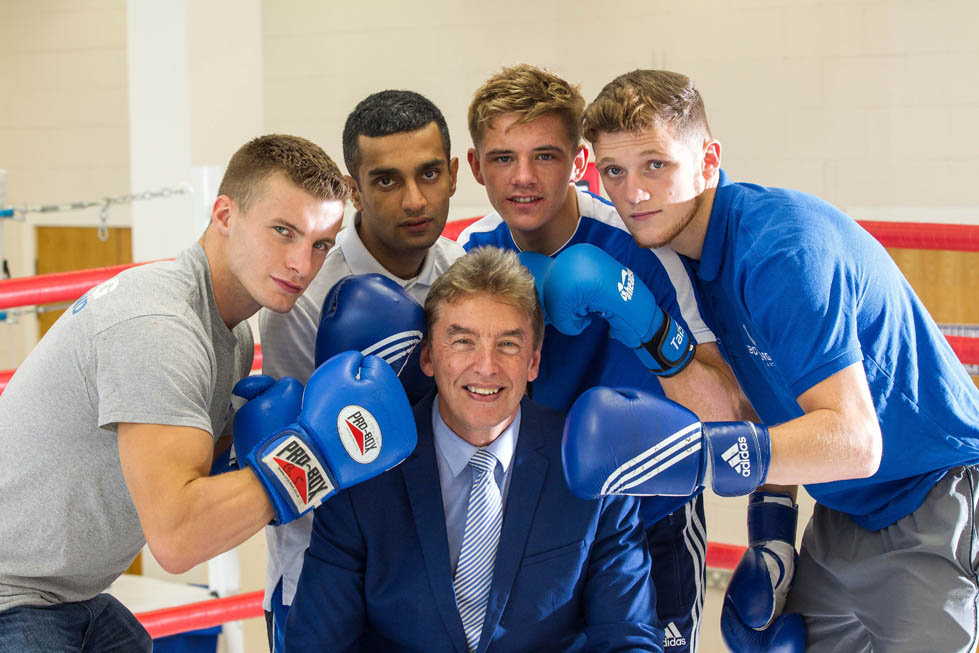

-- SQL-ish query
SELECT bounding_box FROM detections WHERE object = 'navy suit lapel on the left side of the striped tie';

[401,396,469,651]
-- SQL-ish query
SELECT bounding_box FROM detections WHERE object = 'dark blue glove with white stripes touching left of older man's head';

[316,274,435,404]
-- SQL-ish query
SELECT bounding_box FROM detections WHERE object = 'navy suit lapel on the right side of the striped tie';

[479,399,550,651]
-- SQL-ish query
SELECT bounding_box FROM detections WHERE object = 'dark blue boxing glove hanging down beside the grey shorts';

[721,492,806,653]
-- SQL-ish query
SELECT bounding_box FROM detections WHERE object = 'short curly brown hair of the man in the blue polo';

[584,70,710,143]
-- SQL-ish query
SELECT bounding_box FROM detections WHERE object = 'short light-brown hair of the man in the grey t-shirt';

[218,134,350,211]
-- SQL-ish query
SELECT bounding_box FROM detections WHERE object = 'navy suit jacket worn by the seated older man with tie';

[285,395,663,653]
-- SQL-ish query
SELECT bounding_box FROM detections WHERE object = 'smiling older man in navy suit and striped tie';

[285,248,663,652]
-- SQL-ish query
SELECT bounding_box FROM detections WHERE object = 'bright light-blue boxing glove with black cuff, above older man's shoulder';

[544,243,695,376]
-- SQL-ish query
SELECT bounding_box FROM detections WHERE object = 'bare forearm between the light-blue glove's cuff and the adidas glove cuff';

[660,342,755,422]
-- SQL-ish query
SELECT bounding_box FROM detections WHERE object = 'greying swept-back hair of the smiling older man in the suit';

[425,247,544,351]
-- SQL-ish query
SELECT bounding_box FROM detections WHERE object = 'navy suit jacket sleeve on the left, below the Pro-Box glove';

[285,492,366,653]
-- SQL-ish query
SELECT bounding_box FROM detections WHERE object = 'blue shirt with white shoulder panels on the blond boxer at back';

[458,189,714,524]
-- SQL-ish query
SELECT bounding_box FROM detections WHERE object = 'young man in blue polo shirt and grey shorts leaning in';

[584,70,979,651]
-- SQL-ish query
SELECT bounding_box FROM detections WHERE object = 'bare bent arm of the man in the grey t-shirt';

[118,424,275,573]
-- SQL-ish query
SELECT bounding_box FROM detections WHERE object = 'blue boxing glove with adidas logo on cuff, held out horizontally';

[561,386,771,499]
